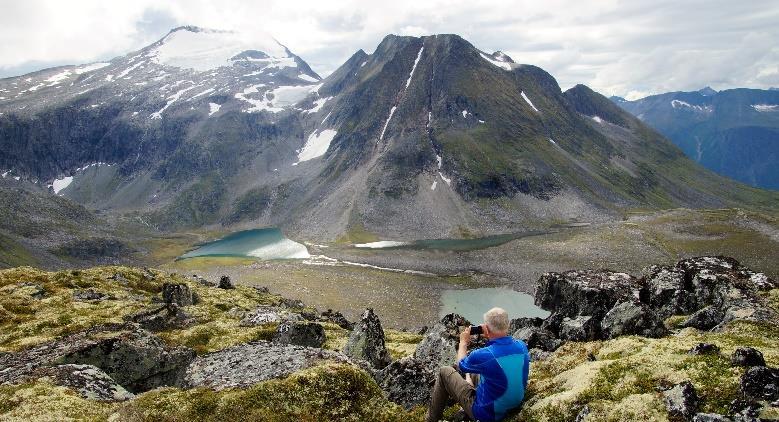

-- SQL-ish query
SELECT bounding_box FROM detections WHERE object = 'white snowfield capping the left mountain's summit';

[150,26,296,72]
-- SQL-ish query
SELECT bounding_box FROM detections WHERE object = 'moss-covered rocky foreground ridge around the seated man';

[0,257,779,420]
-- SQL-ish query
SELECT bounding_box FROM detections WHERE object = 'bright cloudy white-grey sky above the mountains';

[0,0,779,98]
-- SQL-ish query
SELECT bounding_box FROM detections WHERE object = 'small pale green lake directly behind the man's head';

[439,287,549,324]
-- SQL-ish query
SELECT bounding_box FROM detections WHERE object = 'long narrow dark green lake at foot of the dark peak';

[354,231,550,251]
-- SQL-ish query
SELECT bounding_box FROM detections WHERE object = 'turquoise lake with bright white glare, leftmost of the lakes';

[178,227,310,259]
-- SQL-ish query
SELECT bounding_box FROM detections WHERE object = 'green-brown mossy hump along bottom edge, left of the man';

[118,364,420,421]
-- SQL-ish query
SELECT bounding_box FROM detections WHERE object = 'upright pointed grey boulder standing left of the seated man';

[344,308,392,369]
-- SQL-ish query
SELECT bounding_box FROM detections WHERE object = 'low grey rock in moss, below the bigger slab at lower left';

[30,365,135,401]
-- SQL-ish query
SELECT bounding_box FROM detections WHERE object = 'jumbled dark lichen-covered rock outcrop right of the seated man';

[528,256,777,351]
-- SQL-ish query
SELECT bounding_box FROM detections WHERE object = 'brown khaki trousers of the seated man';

[426,366,478,422]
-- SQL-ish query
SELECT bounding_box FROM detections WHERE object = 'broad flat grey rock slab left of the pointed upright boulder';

[185,341,350,390]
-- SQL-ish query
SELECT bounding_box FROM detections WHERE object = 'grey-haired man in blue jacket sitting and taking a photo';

[427,308,530,422]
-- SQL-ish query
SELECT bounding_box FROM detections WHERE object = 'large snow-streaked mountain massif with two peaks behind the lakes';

[0,27,779,258]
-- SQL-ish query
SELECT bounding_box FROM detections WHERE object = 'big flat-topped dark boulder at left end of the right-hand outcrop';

[535,270,641,318]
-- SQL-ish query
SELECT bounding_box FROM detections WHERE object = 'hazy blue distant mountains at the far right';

[612,87,779,190]
